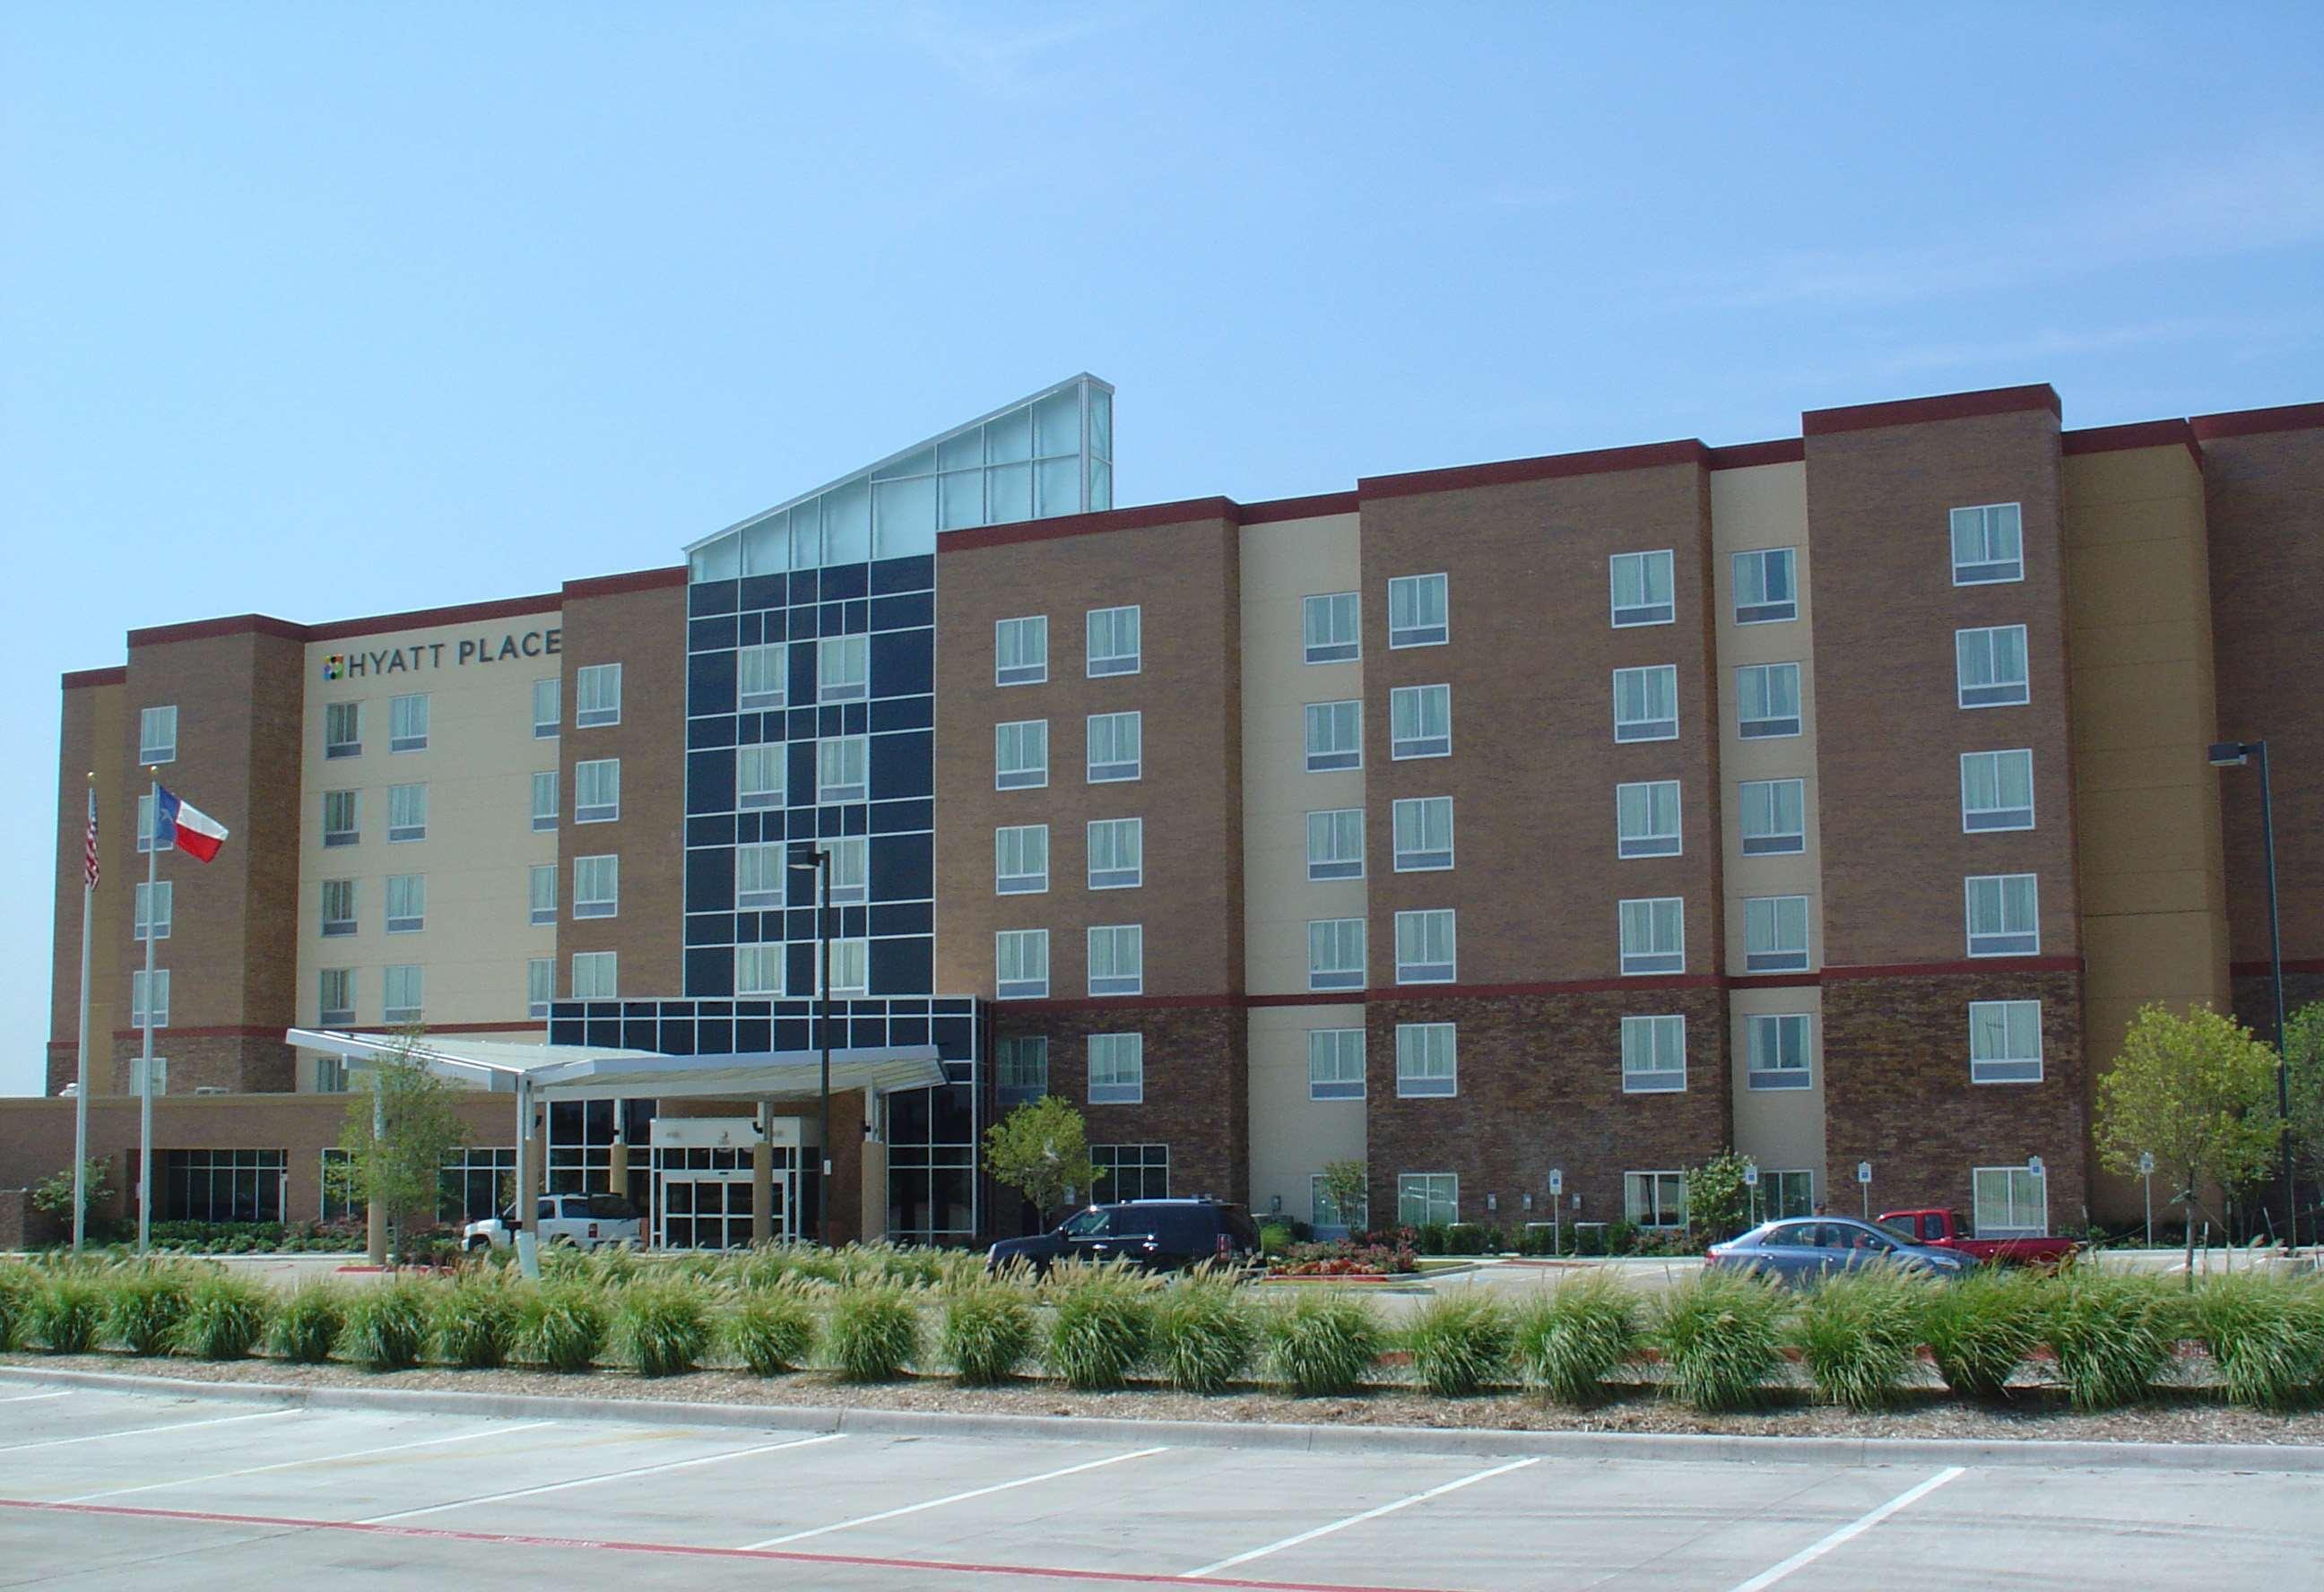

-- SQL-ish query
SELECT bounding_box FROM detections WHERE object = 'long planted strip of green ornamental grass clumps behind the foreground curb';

[13,1246,2324,1441]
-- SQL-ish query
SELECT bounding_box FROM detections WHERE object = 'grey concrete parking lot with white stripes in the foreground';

[0,1378,2324,1592]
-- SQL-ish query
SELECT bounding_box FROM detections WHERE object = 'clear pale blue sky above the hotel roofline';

[0,4,2324,1090]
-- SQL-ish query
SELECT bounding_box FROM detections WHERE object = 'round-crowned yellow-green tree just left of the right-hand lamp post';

[2096,1004,2285,1287]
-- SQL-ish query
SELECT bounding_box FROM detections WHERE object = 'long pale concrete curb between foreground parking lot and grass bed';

[0,1367,2324,1475]
